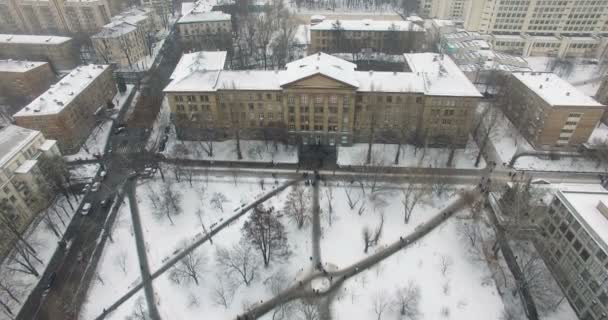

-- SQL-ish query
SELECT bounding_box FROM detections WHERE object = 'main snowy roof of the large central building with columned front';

[165,53,481,97]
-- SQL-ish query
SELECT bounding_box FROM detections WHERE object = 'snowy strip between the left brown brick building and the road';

[64,84,134,161]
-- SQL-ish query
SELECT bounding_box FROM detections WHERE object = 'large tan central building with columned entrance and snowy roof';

[164,53,481,146]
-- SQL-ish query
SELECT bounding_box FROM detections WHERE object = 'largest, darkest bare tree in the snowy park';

[243,205,290,267]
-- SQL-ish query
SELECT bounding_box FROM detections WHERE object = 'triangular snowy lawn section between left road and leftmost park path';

[80,200,141,319]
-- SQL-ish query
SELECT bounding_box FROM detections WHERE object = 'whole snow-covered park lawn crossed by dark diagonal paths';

[81,170,503,320]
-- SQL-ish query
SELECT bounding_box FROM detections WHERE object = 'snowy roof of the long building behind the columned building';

[310,19,424,31]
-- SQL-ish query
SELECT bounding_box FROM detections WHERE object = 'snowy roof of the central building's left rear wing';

[169,51,226,80]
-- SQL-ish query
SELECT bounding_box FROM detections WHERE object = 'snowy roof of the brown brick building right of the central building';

[513,72,602,107]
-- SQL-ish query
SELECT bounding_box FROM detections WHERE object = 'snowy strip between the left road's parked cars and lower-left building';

[0,196,82,320]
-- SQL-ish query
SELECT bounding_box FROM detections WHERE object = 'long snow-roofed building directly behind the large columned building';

[308,20,425,54]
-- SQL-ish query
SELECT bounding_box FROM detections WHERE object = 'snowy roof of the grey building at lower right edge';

[557,184,608,248]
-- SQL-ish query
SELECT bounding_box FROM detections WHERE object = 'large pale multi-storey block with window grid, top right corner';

[464,0,608,36]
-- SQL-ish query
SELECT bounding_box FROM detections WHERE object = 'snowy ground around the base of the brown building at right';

[490,105,608,172]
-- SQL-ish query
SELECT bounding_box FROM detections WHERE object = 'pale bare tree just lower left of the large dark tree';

[216,242,258,286]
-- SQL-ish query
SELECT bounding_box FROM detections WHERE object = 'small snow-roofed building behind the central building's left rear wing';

[176,7,232,51]
